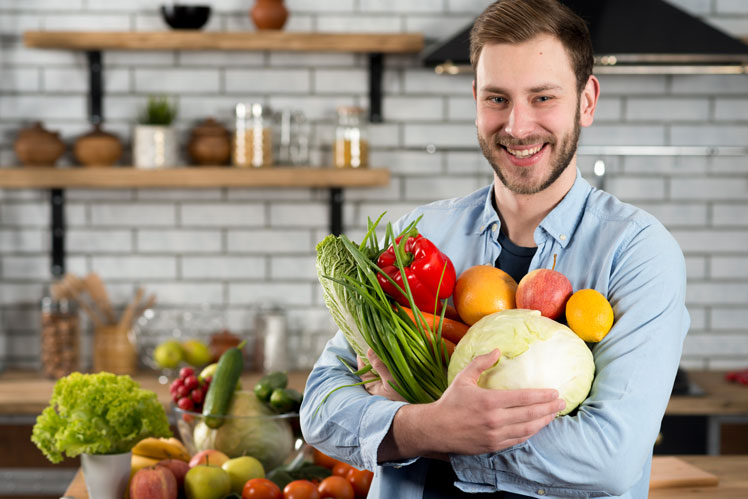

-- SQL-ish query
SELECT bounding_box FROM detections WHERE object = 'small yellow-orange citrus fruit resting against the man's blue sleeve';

[566,289,613,343]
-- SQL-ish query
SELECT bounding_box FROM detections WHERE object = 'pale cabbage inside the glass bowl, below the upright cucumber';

[193,390,294,470]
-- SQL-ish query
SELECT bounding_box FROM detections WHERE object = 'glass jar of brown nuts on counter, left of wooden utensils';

[41,296,80,379]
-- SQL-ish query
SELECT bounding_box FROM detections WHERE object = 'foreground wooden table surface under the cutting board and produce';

[65,455,748,499]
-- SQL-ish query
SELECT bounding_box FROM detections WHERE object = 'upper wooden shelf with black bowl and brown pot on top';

[23,31,424,53]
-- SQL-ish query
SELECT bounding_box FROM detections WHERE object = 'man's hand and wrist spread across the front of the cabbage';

[378,349,566,462]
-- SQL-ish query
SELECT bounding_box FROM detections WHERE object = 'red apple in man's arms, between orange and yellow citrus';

[515,269,574,319]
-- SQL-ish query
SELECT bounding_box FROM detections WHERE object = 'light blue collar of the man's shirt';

[473,168,592,248]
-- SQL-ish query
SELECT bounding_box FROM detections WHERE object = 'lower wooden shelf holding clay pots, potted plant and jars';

[0,166,390,189]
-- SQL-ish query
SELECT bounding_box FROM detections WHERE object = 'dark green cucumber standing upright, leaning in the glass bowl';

[203,343,244,428]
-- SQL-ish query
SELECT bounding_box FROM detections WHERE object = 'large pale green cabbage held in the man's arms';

[448,309,595,415]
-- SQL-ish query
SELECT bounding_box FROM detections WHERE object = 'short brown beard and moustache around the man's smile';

[478,106,581,194]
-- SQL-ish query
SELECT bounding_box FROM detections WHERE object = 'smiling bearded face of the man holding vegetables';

[473,35,597,194]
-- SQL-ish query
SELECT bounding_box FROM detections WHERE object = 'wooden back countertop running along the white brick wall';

[0,371,748,416]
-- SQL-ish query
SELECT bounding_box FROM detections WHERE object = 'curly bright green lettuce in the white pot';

[31,372,172,463]
